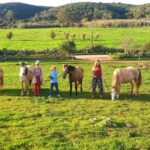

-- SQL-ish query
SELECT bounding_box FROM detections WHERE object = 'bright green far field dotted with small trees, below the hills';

[0,27,150,50]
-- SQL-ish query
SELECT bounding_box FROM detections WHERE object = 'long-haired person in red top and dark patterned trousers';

[92,60,103,97]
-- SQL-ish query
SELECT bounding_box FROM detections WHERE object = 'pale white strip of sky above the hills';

[0,0,150,6]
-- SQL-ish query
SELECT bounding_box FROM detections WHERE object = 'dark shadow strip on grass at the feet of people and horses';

[0,88,150,102]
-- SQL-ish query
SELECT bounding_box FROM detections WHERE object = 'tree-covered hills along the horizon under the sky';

[0,2,150,27]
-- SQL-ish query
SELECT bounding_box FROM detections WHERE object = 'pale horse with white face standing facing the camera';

[19,62,34,96]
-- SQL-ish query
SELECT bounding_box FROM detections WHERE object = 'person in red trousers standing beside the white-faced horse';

[33,60,43,96]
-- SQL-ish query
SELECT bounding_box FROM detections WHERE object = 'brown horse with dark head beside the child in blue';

[63,64,83,95]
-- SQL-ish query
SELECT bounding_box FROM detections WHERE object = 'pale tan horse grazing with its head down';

[111,67,142,100]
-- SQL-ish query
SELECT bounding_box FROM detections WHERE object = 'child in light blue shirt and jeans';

[48,66,60,98]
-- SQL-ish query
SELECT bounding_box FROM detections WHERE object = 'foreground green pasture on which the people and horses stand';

[0,60,150,150]
